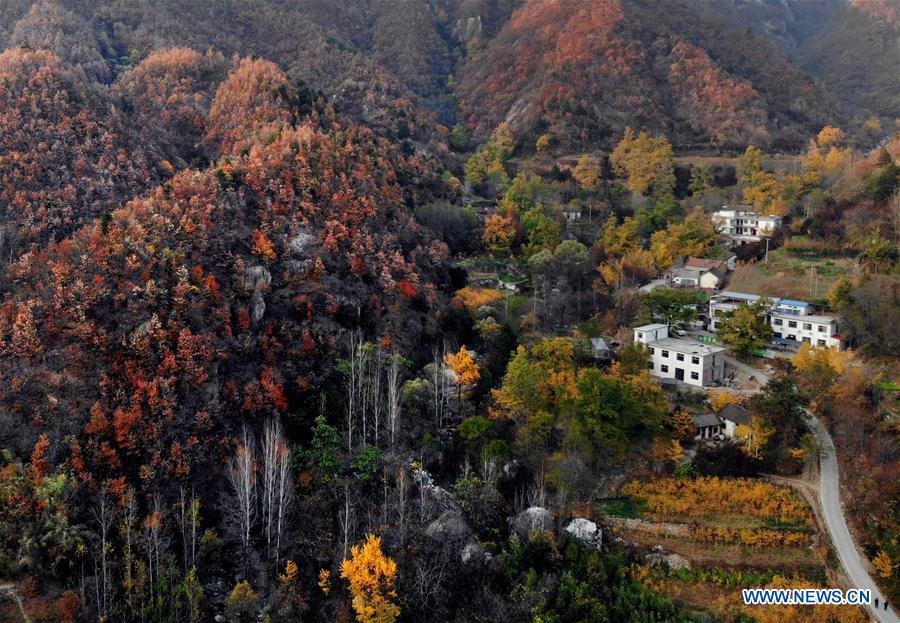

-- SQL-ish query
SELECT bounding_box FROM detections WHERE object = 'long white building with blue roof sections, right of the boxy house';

[709,291,844,350]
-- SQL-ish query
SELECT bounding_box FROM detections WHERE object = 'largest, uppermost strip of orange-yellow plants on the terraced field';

[622,477,810,525]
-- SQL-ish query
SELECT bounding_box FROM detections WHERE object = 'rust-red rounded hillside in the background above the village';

[460,0,834,148]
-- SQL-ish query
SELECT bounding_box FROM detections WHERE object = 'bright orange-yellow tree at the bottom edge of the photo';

[341,534,400,623]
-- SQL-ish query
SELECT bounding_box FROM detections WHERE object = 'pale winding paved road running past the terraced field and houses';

[725,357,900,623]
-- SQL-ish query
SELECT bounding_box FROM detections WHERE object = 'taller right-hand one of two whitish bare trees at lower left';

[262,418,293,569]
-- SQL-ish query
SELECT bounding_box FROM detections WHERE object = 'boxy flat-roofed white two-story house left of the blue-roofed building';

[634,324,725,387]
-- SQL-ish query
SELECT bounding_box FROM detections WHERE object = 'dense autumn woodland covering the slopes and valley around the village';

[0,0,900,623]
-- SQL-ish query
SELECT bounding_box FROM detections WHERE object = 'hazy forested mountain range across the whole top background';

[0,0,900,157]
